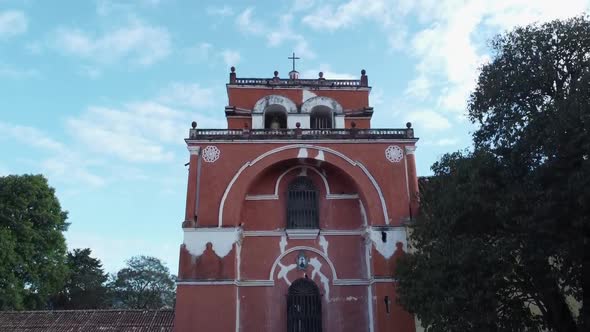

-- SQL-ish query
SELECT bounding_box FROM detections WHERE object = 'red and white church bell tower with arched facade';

[175,63,418,332]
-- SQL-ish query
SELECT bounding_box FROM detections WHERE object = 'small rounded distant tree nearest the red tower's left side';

[112,256,176,309]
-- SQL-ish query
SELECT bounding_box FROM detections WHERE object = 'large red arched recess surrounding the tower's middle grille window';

[240,159,366,230]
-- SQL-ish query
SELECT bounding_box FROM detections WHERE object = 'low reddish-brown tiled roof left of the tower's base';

[0,310,174,332]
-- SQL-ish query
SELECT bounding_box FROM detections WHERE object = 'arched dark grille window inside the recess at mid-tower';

[287,176,319,229]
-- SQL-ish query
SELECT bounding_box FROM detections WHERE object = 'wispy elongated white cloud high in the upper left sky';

[55,20,171,66]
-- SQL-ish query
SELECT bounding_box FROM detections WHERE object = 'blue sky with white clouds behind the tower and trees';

[0,0,590,273]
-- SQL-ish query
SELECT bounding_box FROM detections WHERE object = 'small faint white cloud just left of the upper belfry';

[158,83,215,109]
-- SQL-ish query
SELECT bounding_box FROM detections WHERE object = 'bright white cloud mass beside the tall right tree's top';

[406,0,590,113]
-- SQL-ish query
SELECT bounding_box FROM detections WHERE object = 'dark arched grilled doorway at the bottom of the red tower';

[287,277,322,332]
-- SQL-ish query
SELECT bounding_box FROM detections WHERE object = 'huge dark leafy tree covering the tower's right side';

[397,16,590,331]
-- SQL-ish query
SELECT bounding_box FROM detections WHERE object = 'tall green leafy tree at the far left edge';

[0,175,68,310]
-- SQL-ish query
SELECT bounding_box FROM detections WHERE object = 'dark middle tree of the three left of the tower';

[53,248,109,310]
